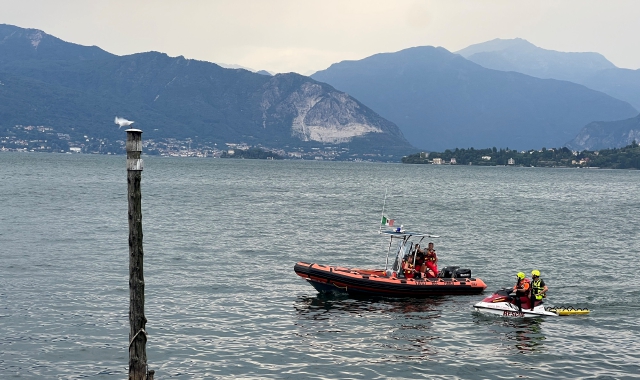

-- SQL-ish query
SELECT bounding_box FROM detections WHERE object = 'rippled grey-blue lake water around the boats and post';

[0,153,640,379]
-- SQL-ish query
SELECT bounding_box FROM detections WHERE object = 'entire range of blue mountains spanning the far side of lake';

[0,25,640,160]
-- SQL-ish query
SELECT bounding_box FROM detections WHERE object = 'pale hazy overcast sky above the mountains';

[0,0,640,74]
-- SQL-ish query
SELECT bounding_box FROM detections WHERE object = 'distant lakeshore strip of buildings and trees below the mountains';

[5,125,640,169]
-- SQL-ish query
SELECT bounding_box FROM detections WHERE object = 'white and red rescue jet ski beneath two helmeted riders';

[473,288,558,318]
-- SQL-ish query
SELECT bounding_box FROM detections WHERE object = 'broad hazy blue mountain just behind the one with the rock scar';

[311,46,638,151]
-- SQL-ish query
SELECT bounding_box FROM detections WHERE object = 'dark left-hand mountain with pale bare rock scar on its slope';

[0,25,415,160]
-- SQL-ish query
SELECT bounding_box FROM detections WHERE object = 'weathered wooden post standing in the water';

[126,129,154,380]
